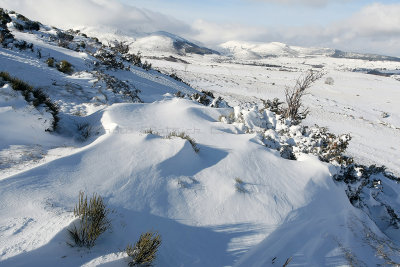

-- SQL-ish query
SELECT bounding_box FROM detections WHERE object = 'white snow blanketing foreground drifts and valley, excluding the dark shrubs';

[0,8,400,267]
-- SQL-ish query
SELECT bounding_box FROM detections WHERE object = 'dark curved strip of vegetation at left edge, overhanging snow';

[0,71,60,131]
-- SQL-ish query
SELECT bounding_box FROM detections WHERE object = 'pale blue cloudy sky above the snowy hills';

[0,0,400,57]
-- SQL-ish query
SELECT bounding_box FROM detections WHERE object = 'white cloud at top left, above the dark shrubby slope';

[0,0,191,33]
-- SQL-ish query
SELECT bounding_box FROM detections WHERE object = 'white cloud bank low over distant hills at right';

[192,4,400,56]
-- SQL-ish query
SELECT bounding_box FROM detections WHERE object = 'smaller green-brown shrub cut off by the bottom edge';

[126,232,161,266]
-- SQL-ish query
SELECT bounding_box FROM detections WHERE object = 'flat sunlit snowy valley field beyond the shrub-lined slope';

[150,52,400,175]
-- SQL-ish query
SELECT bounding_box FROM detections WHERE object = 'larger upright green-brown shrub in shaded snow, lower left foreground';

[68,192,111,248]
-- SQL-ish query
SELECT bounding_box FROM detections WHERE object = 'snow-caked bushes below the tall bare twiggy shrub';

[219,100,352,164]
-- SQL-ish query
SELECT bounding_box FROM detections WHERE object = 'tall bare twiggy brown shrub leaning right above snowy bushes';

[284,70,324,124]
